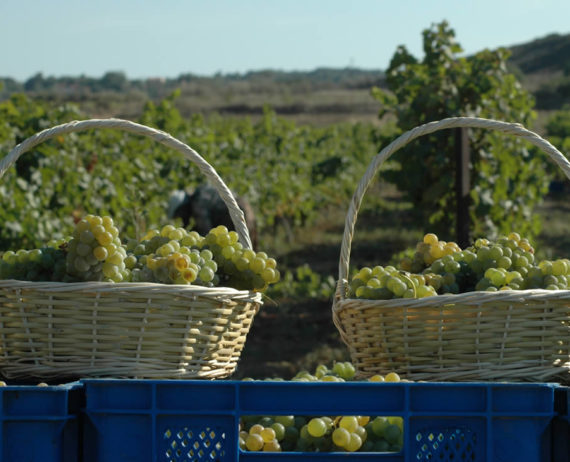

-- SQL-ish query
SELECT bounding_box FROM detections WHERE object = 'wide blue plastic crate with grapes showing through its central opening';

[83,380,558,462]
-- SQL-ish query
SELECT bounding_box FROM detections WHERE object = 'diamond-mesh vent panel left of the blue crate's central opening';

[164,427,226,462]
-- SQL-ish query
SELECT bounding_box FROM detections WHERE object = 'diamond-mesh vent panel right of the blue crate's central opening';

[415,428,477,462]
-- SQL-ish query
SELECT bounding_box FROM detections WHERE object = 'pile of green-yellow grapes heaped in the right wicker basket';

[349,232,570,300]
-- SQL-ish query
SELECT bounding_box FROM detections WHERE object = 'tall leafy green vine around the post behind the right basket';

[373,21,548,237]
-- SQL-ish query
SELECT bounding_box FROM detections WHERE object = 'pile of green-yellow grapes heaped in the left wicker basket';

[0,215,280,291]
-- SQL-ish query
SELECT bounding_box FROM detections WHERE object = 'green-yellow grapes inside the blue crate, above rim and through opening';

[239,362,404,452]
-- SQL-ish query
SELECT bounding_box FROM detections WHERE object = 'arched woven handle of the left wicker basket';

[0,119,252,249]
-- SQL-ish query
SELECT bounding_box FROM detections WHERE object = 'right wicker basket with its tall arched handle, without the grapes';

[332,117,570,381]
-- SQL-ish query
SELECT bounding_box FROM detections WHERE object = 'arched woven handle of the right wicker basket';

[335,117,570,300]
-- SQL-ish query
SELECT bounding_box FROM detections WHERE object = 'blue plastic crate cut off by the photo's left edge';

[0,382,83,462]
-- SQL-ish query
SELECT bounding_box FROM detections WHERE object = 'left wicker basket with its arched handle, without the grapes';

[0,119,262,379]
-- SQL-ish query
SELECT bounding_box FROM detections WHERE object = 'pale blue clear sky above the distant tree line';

[0,0,570,81]
